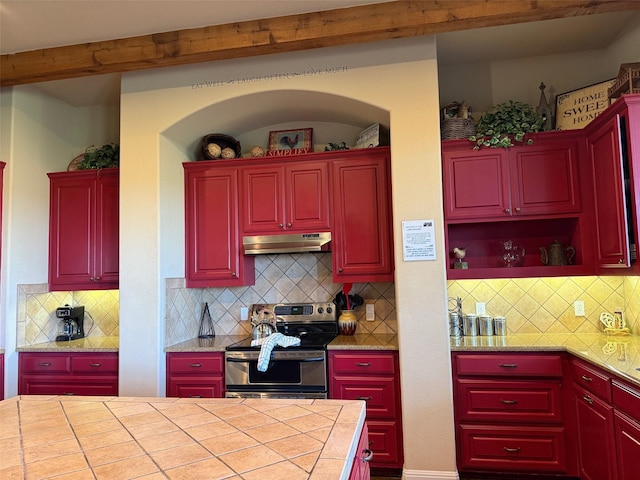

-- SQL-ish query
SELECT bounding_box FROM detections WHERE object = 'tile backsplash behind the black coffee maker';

[17,283,120,347]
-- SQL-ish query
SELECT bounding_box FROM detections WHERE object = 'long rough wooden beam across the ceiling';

[0,0,640,87]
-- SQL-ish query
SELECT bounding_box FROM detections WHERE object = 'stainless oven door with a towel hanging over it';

[225,350,327,394]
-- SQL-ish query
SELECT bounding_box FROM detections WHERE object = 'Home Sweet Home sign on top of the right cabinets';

[556,78,616,130]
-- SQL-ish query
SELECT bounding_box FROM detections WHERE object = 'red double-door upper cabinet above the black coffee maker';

[48,168,119,291]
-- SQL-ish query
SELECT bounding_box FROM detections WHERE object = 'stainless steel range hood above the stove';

[242,232,331,255]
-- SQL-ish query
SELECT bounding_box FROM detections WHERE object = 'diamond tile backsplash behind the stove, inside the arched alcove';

[165,253,397,346]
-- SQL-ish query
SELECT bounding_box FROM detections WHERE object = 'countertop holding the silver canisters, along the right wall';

[450,333,640,386]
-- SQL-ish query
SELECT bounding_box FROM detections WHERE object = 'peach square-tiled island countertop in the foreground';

[0,395,365,480]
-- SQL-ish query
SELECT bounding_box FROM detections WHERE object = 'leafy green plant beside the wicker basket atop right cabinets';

[469,100,544,150]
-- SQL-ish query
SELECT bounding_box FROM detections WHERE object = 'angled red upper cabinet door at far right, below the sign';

[587,115,631,268]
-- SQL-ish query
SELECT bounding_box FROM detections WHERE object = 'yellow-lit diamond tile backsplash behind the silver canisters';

[447,276,640,335]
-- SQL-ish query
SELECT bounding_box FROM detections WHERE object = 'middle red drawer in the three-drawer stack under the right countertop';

[456,379,563,423]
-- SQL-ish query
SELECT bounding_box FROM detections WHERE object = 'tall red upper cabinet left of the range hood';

[183,161,255,288]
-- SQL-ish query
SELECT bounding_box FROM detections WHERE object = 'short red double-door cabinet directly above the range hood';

[240,161,330,235]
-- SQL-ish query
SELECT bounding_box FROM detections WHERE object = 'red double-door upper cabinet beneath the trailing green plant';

[442,132,584,220]
